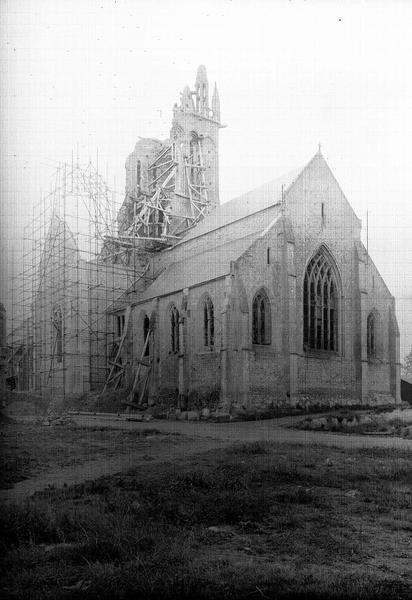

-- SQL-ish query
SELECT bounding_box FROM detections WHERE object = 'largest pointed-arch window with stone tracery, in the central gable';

[303,250,338,352]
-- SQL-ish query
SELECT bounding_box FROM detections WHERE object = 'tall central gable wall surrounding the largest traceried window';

[285,154,361,405]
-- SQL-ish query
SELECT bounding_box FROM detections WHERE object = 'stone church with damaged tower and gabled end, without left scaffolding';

[21,67,400,412]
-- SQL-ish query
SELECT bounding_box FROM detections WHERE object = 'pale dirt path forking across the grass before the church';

[0,415,412,503]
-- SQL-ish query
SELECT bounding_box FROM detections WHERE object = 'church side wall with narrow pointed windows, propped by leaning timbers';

[123,280,227,408]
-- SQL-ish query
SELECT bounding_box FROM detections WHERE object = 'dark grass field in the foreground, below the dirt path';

[1,436,412,600]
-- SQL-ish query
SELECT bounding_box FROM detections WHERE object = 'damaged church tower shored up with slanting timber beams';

[112,66,222,262]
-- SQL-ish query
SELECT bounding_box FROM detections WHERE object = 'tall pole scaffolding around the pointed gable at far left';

[8,159,139,396]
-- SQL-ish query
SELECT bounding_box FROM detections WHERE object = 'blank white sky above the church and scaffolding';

[0,0,412,357]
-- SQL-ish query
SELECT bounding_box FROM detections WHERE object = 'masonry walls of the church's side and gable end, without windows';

[107,154,398,410]
